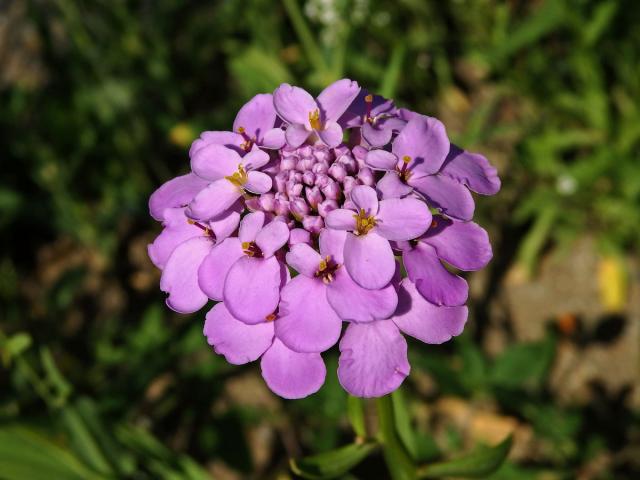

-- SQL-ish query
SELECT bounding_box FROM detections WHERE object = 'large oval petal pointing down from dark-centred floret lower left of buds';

[223,256,282,324]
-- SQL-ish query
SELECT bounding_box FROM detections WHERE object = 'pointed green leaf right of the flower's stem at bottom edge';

[418,435,512,478]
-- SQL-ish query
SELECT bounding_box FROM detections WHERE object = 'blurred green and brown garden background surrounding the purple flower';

[0,0,640,480]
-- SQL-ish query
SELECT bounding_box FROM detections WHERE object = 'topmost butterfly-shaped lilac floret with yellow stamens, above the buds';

[273,79,360,148]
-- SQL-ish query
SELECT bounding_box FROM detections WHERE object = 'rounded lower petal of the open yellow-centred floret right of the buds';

[344,232,396,290]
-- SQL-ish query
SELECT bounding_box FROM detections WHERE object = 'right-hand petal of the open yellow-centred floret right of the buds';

[376,198,431,240]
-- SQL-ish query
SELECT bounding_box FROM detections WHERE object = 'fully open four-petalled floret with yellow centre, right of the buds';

[327,185,431,289]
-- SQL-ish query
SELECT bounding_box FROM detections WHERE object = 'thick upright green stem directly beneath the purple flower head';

[376,395,416,480]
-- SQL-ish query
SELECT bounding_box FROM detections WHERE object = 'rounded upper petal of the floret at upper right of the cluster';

[393,115,450,174]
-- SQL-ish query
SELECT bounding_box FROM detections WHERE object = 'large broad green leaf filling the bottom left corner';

[0,426,104,480]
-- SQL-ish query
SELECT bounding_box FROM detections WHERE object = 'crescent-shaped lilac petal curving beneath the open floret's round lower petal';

[327,268,398,322]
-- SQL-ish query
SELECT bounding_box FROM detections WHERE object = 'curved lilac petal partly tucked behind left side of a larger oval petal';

[198,237,244,301]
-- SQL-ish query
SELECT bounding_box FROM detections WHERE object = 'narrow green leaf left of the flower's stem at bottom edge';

[290,442,378,478]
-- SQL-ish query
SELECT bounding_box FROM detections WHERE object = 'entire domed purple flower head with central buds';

[149,79,500,398]
